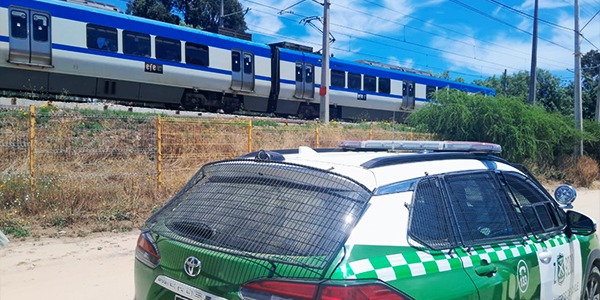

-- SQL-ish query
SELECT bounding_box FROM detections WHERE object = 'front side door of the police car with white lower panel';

[501,172,582,299]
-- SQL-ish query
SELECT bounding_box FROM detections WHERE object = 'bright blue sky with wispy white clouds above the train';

[100,0,600,84]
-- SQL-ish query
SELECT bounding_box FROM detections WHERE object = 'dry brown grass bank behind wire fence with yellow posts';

[0,108,430,236]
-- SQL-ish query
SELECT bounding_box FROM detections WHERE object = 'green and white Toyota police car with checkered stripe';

[135,141,600,300]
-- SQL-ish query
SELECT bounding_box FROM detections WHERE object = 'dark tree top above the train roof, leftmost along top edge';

[126,0,179,24]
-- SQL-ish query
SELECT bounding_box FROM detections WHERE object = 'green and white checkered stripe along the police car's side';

[332,234,569,281]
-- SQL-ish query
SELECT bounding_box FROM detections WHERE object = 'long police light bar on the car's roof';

[338,140,502,153]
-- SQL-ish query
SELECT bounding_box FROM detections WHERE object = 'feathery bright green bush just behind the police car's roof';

[407,90,582,165]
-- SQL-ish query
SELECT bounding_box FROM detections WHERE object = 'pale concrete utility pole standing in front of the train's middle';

[319,0,330,124]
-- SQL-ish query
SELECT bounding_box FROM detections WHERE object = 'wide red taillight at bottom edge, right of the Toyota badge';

[240,281,410,300]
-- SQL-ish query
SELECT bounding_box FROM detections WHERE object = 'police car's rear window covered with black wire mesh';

[147,160,371,268]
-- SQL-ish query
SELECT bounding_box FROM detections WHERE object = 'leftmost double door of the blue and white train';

[8,7,52,66]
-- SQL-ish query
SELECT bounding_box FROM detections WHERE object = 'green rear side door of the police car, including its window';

[444,171,541,299]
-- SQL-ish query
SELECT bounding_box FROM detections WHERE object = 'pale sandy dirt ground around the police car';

[0,189,600,300]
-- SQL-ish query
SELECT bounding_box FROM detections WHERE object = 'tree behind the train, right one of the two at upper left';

[173,0,248,32]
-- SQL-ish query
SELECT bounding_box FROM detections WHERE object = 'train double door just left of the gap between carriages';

[231,50,254,92]
